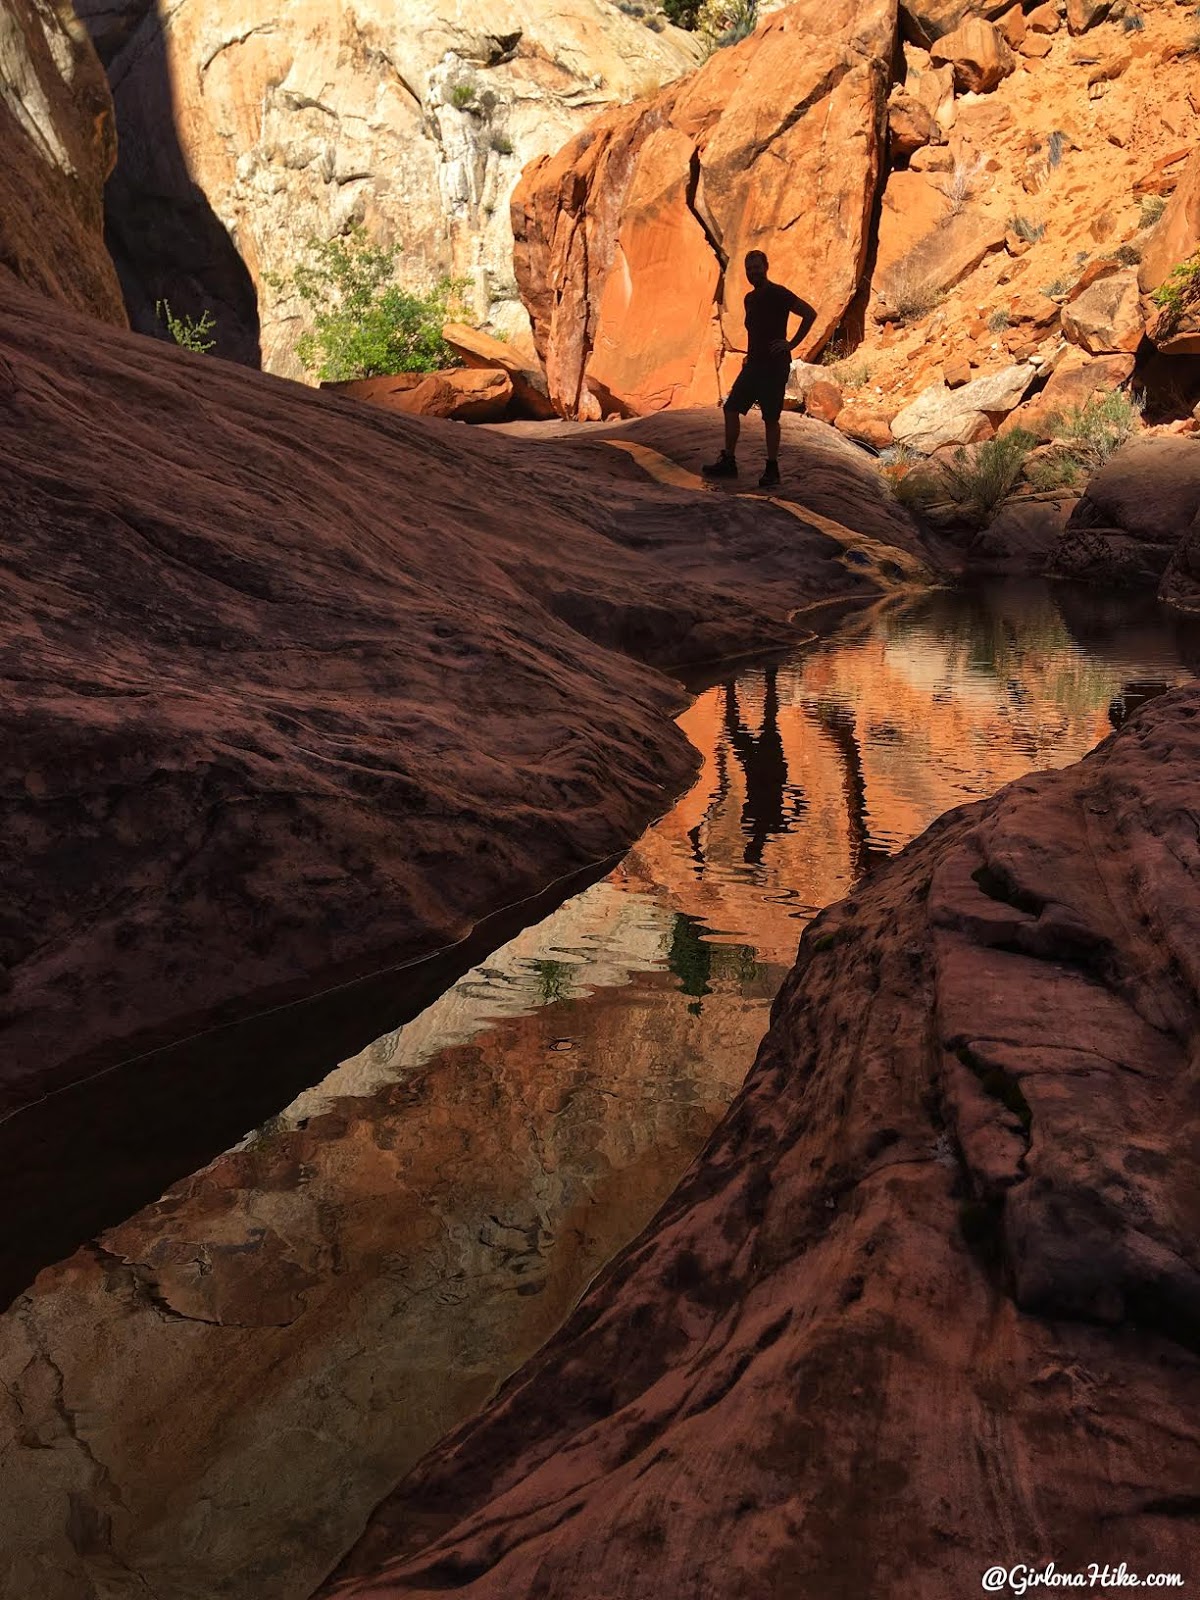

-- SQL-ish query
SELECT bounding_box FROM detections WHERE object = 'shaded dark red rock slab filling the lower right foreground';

[322,690,1200,1600]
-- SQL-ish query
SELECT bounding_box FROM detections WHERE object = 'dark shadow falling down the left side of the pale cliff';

[77,0,262,366]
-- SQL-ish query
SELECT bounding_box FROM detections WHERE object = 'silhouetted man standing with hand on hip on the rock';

[701,250,816,490]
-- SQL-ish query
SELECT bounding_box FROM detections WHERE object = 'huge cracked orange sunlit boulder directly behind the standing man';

[512,0,894,418]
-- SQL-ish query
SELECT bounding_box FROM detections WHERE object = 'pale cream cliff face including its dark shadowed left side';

[72,0,696,376]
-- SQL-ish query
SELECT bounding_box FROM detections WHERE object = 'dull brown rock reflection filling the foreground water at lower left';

[0,934,761,1600]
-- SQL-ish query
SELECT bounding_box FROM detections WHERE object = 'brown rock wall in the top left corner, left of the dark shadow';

[0,0,125,323]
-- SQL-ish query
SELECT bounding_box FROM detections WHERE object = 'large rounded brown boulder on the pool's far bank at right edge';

[1051,435,1200,590]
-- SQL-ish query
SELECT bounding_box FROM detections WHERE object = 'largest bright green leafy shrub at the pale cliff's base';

[270,227,466,382]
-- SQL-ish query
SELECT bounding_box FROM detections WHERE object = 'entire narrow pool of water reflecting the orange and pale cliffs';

[0,584,1200,1600]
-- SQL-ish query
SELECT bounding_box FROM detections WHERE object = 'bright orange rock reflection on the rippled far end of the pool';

[629,589,1139,963]
